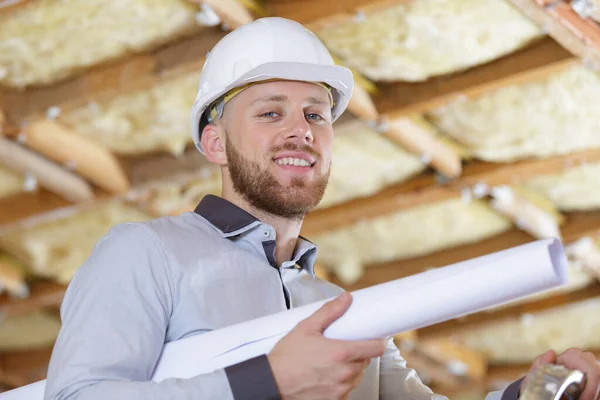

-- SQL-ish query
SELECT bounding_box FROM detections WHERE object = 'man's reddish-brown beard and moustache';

[225,137,329,220]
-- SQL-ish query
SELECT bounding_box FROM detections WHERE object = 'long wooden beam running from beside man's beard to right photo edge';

[302,149,600,237]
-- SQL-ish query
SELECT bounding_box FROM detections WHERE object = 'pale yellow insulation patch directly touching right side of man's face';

[319,120,426,208]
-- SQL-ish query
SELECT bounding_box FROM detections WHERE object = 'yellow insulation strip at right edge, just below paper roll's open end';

[453,298,600,363]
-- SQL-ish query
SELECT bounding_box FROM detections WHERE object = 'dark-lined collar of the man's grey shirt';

[194,194,317,276]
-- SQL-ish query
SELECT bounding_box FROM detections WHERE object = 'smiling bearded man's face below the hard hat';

[203,81,333,219]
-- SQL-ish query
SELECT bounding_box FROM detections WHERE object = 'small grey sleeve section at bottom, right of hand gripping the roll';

[379,338,448,400]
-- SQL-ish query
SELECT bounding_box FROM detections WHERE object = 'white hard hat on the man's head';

[190,17,354,152]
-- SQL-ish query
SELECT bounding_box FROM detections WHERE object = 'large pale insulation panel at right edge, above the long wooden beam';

[429,65,600,162]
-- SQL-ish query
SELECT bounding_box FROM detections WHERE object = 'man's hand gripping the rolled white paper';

[267,292,386,400]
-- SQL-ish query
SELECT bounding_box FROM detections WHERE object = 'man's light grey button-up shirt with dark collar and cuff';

[44,196,518,400]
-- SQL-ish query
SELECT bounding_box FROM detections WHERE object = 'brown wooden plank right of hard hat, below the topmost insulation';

[373,38,579,119]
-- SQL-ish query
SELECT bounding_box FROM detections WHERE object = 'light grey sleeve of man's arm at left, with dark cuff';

[44,223,274,400]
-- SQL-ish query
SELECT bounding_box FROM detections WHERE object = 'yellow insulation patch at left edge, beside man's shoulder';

[0,201,151,283]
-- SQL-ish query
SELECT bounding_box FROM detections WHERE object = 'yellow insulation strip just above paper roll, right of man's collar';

[314,198,512,275]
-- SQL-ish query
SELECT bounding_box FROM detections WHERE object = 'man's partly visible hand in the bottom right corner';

[521,348,600,400]
